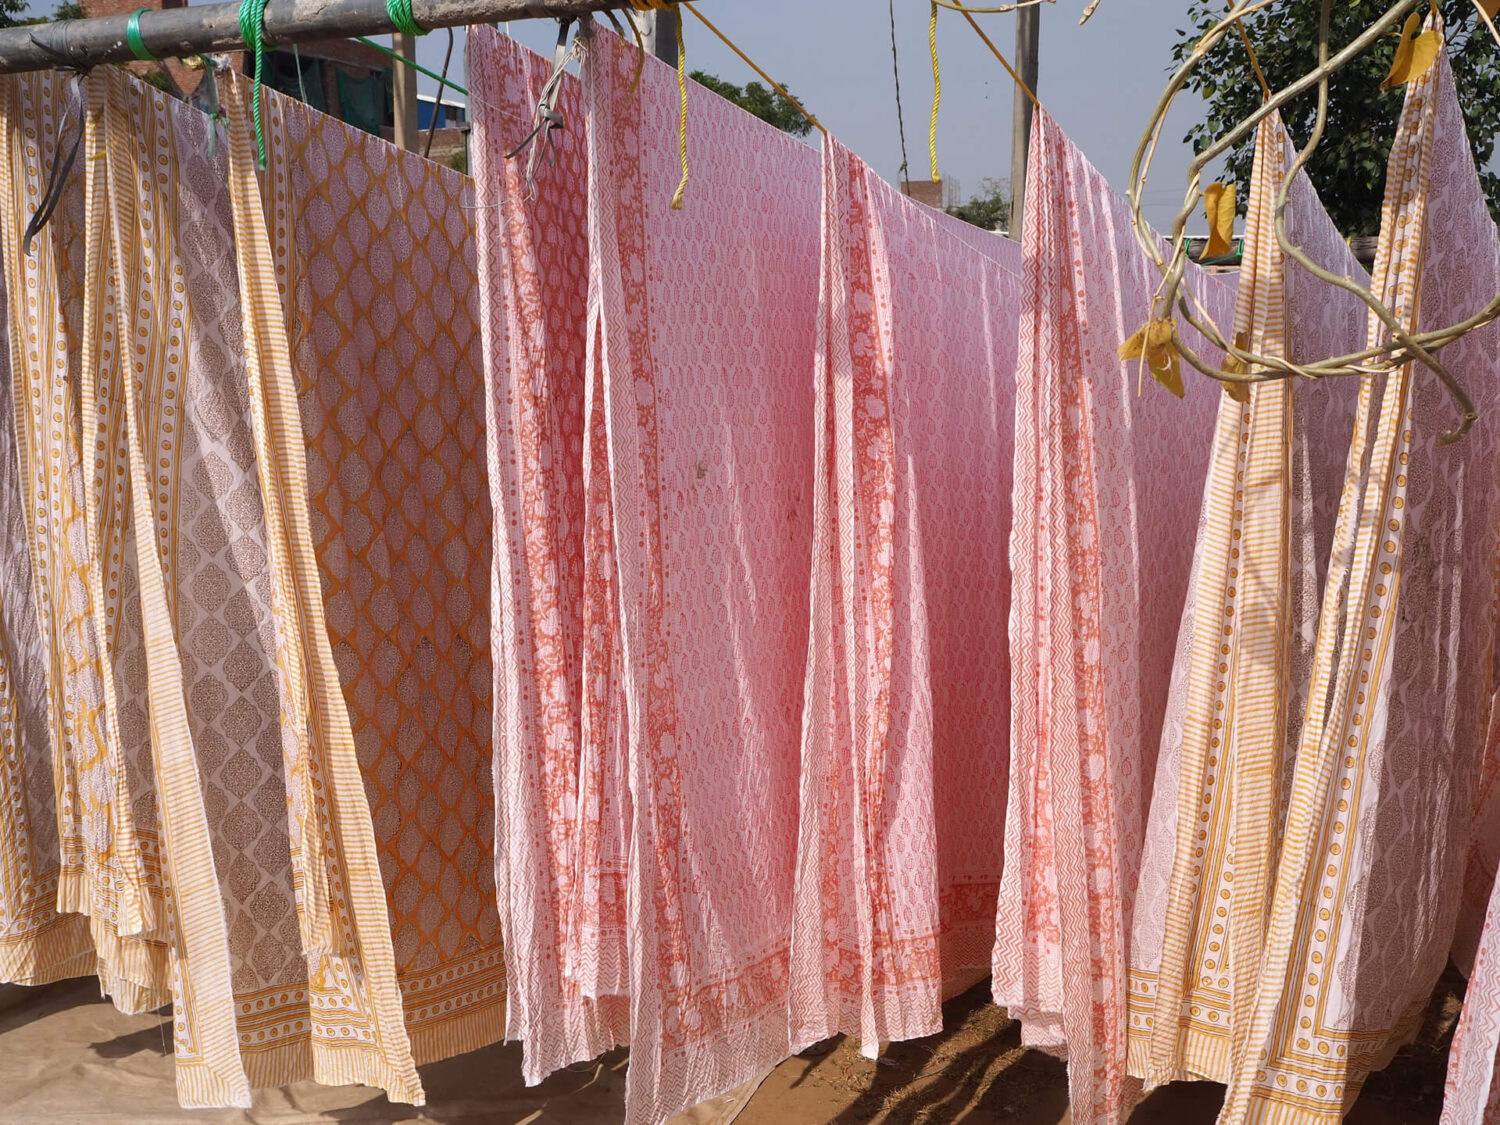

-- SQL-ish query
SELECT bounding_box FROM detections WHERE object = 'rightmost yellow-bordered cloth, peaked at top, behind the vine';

[1221,39,1500,1125]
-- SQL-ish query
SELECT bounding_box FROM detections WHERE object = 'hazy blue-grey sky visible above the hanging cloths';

[402,0,1230,230]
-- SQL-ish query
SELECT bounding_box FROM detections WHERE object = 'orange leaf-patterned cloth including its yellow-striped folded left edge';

[222,68,506,1101]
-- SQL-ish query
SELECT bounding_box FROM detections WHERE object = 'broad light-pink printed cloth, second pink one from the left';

[584,32,819,1125]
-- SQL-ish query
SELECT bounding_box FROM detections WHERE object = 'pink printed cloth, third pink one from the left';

[791,138,1020,1056]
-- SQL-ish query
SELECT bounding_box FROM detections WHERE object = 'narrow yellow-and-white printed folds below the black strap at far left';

[0,74,171,1014]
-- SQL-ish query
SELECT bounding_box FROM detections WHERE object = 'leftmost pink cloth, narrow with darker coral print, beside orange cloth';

[468,27,629,1083]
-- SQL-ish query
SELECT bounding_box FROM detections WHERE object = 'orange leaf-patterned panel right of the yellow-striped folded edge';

[246,79,506,1062]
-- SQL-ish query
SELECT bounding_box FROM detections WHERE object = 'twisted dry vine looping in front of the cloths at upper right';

[1128,0,1500,441]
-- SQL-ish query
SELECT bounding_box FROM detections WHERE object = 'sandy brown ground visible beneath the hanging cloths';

[0,974,1463,1125]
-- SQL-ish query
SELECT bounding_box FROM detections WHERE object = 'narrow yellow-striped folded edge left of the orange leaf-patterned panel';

[224,78,423,1104]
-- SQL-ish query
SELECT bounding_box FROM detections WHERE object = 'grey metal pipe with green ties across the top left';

[0,0,626,74]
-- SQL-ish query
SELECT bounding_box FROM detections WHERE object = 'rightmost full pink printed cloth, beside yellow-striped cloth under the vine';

[993,113,1235,1122]
